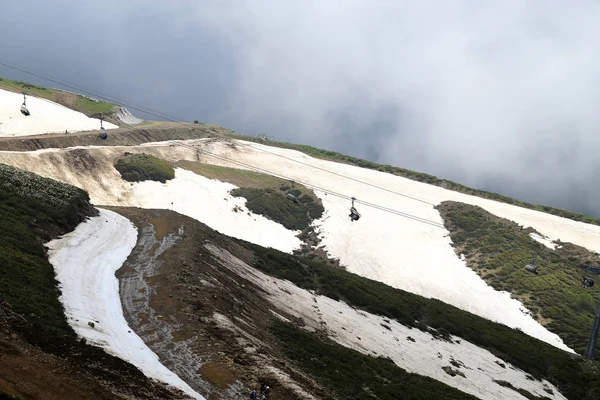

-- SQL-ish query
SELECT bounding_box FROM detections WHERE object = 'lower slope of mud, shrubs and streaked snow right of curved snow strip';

[113,208,599,399]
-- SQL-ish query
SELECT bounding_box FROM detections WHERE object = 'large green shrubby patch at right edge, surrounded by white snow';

[437,202,600,354]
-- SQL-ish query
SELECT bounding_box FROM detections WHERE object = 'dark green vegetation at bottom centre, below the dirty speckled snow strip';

[270,320,476,400]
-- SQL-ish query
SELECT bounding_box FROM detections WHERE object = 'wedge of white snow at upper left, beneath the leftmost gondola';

[0,89,118,137]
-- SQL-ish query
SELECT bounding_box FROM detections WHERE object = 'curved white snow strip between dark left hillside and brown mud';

[46,209,204,400]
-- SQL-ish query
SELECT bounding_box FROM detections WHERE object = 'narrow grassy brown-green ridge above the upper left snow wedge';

[0,78,117,116]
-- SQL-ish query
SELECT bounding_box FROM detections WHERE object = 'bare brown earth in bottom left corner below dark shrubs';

[0,307,183,400]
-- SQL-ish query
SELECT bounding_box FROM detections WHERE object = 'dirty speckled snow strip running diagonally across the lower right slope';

[205,243,566,400]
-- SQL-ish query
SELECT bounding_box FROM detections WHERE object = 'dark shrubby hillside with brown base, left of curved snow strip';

[0,164,183,400]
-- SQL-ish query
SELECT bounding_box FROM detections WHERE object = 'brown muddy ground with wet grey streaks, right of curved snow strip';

[106,207,330,400]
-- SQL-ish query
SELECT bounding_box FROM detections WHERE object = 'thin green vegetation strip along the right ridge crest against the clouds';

[230,132,600,225]
